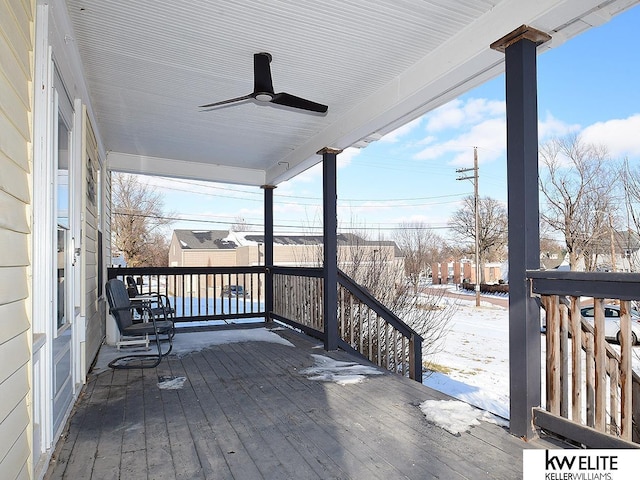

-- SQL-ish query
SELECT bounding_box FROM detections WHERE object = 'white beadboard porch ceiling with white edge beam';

[67,0,637,185]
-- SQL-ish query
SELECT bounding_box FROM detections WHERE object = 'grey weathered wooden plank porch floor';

[45,324,556,480]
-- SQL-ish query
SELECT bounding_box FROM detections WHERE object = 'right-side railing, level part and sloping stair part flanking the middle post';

[272,267,422,381]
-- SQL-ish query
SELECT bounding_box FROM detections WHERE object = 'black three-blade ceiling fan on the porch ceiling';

[200,52,329,113]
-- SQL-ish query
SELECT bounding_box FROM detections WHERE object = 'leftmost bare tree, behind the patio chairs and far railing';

[111,173,173,267]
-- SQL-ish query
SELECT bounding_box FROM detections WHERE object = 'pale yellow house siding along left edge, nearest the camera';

[0,0,35,479]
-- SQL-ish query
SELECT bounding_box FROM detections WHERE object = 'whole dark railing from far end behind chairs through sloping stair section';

[108,267,422,381]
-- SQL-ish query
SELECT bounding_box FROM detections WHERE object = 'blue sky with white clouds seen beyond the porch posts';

[142,6,640,238]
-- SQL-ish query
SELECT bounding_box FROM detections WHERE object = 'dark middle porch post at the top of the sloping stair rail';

[318,148,342,350]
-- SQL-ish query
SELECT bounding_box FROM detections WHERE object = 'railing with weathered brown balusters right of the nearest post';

[528,271,640,447]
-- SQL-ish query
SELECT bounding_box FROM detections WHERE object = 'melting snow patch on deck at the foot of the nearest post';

[420,400,506,435]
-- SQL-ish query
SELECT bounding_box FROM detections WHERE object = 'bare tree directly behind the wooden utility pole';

[449,196,507,282]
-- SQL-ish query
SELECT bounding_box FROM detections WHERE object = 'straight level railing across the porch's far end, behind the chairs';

[108,267,266,322]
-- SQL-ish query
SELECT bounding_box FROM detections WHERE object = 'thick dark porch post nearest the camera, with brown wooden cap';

[491,25,550,439]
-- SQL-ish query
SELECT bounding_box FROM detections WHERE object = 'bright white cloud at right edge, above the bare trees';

[581,114,640,158]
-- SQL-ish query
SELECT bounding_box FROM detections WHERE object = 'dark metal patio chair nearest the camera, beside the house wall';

[106,278,175,368]
